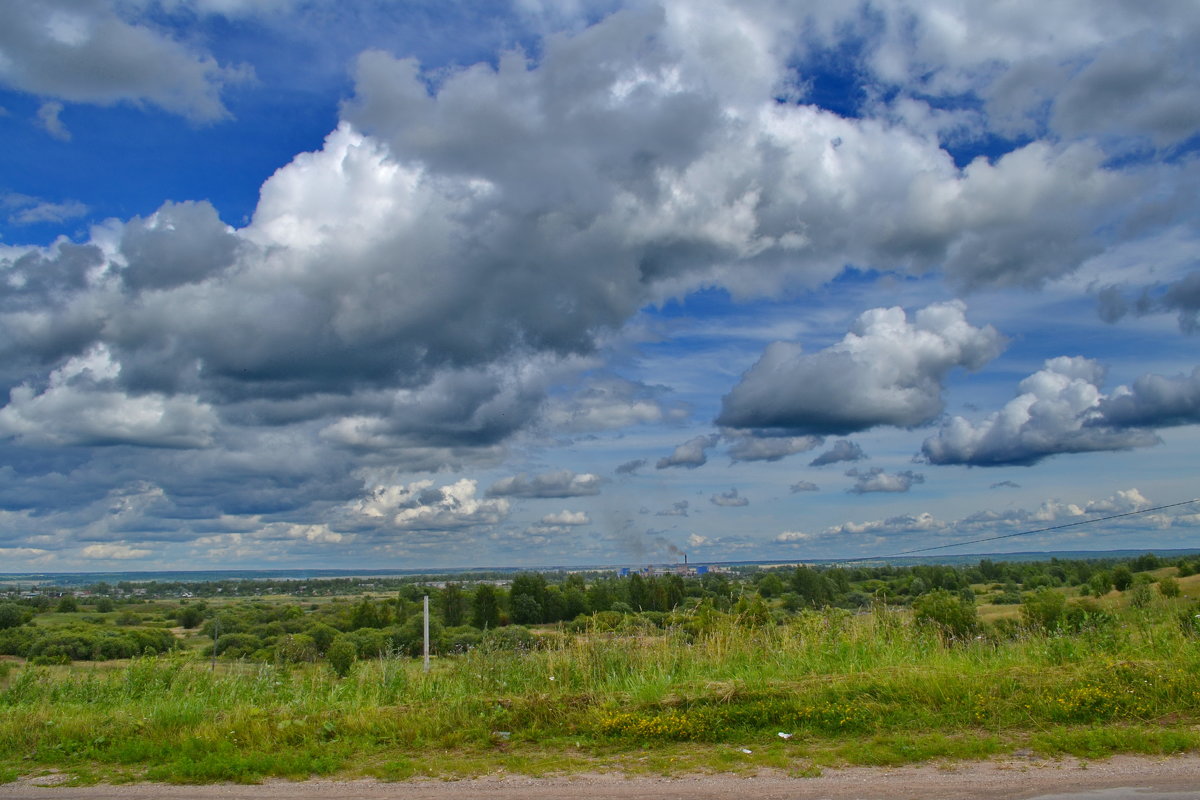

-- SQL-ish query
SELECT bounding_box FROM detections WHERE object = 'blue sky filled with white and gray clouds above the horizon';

[0,0,1200,572]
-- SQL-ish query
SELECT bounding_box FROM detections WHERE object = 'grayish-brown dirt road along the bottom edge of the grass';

[0,756,1200,800]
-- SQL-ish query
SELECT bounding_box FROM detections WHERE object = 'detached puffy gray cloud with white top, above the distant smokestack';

[716,302,1002,435]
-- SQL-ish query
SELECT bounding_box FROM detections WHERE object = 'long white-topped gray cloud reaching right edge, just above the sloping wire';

[922,356,1171,467]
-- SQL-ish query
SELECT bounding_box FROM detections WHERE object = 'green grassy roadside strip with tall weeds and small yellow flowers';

[0,603,1200,783]
